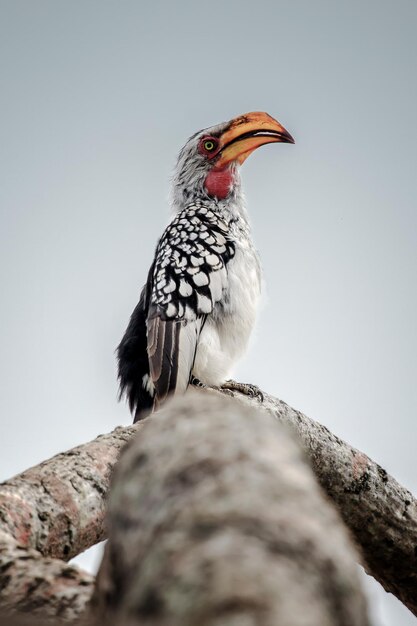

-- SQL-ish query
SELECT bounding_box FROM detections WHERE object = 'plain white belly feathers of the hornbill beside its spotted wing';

[193,243,261,385]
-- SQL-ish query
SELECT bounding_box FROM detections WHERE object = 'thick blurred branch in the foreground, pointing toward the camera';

[93,394,368,626]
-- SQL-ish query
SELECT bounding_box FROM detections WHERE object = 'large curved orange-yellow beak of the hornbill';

[215,111,295,169]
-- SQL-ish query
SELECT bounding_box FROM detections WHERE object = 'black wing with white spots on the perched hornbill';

[147,204,235,403]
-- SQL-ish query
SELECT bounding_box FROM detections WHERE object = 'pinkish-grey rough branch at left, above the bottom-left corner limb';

[0,426,136,561]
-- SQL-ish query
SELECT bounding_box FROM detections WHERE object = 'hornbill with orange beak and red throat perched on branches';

[116,111,294,422]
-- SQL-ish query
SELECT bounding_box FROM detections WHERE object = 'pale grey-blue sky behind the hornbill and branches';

[0,0,417,626]
